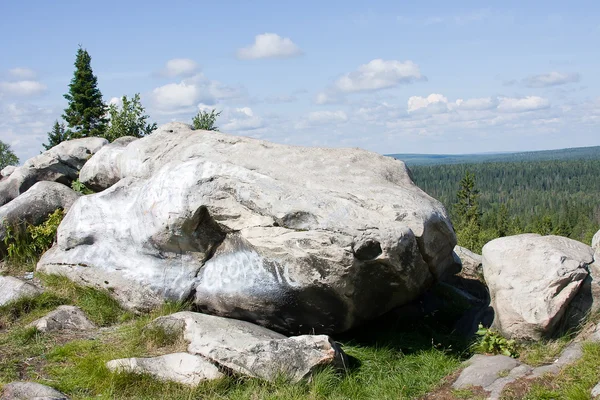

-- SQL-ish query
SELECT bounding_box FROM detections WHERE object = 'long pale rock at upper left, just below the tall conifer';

[0,137,108,206]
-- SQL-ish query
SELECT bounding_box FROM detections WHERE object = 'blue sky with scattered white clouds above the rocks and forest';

[0,0,600,161]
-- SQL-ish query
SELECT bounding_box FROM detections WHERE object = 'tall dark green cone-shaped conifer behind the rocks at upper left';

[63,47,107,139]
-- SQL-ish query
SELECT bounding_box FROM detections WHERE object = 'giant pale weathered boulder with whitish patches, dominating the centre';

[38,123,455,333]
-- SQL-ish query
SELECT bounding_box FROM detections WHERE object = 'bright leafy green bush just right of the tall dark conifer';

[104,93,156,142]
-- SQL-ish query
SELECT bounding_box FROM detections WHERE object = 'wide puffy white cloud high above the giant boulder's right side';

[334,59,427,93]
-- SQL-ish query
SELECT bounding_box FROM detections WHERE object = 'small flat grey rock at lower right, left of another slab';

[452,354,521,389]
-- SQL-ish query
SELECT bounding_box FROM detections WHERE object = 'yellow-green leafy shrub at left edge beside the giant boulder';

[4,208,64,264]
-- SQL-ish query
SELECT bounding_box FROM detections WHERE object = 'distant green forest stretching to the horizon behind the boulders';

[410,159,600,251]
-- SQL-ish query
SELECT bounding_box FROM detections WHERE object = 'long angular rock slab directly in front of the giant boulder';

[152,312,347,382]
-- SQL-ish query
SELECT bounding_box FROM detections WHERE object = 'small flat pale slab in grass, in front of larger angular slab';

[106,353,225,386]
